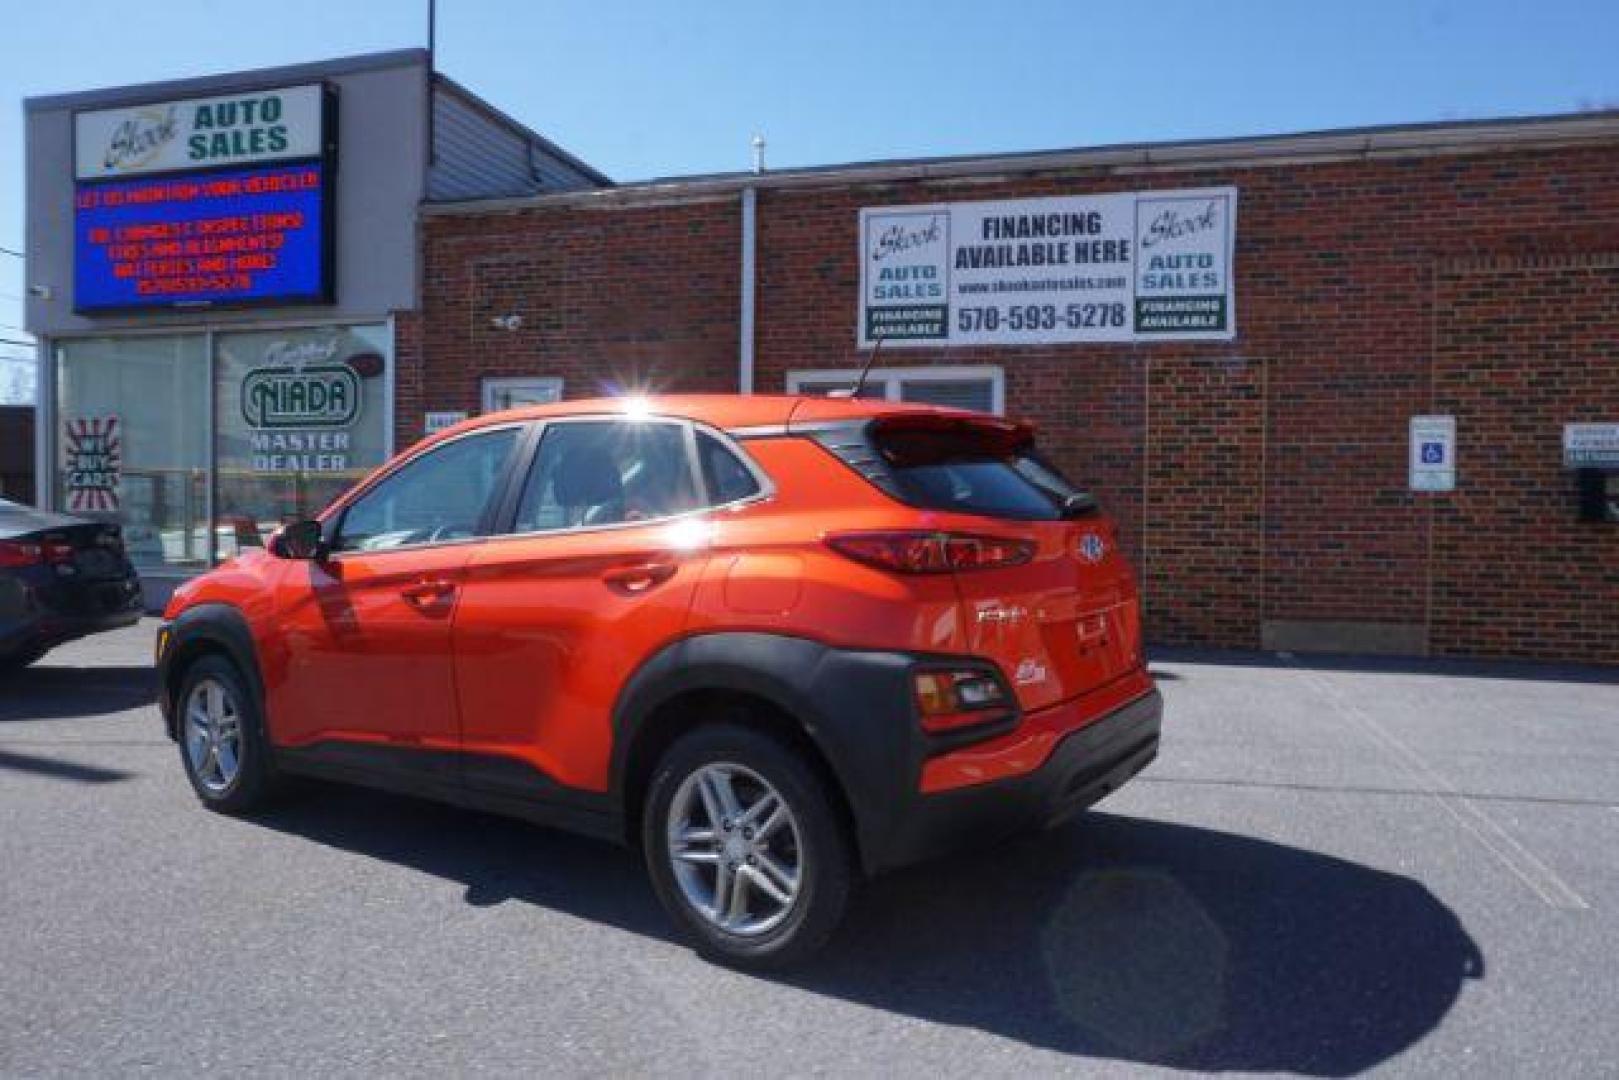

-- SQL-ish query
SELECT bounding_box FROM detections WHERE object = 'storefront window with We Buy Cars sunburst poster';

[57,334,207,570]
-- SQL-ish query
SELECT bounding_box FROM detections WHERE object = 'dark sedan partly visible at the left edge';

[0,499,142,672]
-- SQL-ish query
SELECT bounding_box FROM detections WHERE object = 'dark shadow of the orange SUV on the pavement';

[257,785,1485,1077]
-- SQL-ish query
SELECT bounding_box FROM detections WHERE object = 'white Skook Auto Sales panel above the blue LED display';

[73,84,325,180]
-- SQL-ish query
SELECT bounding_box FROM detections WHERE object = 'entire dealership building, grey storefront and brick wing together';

[25,50,1619,662]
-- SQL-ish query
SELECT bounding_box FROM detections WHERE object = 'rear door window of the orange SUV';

[513,419,698,533]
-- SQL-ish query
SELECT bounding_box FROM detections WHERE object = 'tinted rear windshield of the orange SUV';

[871,424,1090,521]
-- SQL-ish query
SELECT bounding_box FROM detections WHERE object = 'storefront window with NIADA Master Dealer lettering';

[214,325,392,559]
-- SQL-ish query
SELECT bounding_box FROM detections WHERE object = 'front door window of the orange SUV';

[337,427,518,551]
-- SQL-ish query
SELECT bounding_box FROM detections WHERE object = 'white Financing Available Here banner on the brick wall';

[858,188,1237,348]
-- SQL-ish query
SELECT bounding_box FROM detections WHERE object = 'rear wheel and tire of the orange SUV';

[641,724,855,970]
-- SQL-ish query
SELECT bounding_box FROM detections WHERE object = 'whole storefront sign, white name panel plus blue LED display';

[73,84,337,314]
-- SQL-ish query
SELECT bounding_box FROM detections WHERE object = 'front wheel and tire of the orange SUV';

[175,654,275,814]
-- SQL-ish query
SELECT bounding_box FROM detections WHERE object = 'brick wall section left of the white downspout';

[397,199,742,445]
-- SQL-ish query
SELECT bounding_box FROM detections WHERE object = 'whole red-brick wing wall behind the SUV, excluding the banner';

[404,115,1619,664]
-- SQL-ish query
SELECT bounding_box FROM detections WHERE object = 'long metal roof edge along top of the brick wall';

[423,110,1619,217]
